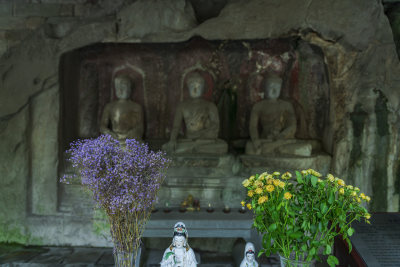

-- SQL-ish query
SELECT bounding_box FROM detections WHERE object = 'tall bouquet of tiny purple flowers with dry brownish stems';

[61,135,170,264]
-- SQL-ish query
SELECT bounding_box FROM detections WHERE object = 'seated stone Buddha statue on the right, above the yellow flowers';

[246,75,312,156]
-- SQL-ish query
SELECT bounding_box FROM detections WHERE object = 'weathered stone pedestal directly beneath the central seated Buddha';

[157,154,245,208]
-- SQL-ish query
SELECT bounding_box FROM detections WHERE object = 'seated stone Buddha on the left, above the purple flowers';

[100,75,144,144]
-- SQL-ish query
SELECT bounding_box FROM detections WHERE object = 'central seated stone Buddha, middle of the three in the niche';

[163,72,228,154]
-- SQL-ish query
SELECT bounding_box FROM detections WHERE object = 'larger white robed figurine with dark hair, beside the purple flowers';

[160,222,197,267]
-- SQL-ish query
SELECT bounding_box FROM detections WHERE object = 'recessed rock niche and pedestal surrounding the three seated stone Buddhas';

[60,38,330,214]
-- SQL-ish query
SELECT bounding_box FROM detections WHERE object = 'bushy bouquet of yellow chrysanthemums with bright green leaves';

[242,169,371,266]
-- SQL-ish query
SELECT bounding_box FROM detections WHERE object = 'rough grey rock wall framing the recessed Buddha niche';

[0,0,400,245]
